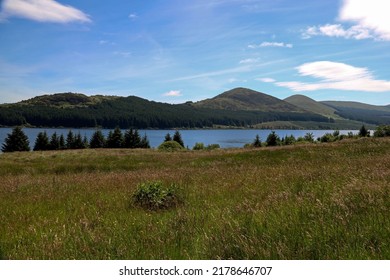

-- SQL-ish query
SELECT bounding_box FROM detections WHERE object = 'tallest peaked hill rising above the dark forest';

[194,88,306,113]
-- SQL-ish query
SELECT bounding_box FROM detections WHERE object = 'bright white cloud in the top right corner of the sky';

[302,0,390,41]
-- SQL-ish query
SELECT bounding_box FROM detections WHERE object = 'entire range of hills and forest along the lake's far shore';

[0,88,384,129]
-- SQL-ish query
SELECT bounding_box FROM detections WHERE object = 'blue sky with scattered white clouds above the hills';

[0,0,390,105]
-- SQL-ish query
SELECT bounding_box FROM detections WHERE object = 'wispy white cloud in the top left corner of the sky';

[0,0,91,23]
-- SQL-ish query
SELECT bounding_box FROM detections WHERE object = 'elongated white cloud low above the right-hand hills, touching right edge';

[275,61,390,92]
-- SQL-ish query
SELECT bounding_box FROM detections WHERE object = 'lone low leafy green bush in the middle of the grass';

[133,181,182,211]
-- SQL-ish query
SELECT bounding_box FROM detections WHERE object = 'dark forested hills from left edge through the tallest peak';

[0,88,328,129]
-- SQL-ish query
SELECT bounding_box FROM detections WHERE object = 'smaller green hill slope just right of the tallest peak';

[284,94,342,119]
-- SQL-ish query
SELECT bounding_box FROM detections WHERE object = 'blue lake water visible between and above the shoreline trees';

[0,128,358,149]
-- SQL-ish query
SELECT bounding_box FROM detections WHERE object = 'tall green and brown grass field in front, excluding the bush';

[0,138,390,259]
